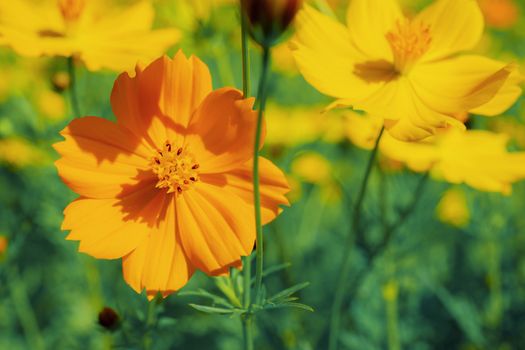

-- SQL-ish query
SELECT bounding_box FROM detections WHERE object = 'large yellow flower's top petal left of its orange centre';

[346,0,403,61]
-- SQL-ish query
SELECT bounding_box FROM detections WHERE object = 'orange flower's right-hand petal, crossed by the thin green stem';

[202,157,290,224]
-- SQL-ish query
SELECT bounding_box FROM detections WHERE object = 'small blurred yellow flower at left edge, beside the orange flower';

[0,137,48,168]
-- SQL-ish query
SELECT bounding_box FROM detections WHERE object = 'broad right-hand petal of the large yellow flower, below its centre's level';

[410,55,517,114]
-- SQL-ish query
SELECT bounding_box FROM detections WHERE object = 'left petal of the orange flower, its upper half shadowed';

[54,117,155,198]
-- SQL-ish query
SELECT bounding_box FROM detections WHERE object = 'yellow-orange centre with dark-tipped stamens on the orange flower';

[150,141,199,194]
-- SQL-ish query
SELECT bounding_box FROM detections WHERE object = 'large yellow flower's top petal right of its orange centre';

[415,0,483,61]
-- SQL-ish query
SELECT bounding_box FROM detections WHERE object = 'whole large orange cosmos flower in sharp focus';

[54,52,288,298]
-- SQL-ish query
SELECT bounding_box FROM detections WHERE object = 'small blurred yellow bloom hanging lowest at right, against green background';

[436,188,470,228]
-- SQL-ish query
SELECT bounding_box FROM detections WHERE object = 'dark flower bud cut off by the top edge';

[241,0,302,47]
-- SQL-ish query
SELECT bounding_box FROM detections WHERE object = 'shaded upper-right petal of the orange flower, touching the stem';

[185,88,264,174]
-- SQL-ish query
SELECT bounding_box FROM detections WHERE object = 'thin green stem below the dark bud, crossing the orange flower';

[253,46,270,302]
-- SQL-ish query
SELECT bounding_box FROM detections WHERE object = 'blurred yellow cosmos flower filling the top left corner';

[0,0,179,71]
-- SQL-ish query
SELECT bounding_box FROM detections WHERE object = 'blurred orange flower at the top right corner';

[478,0,519,29]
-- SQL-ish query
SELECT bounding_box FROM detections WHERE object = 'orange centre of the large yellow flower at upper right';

[386,19,432,73]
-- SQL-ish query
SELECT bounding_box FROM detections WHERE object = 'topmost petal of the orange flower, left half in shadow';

[111,51,212,147]
